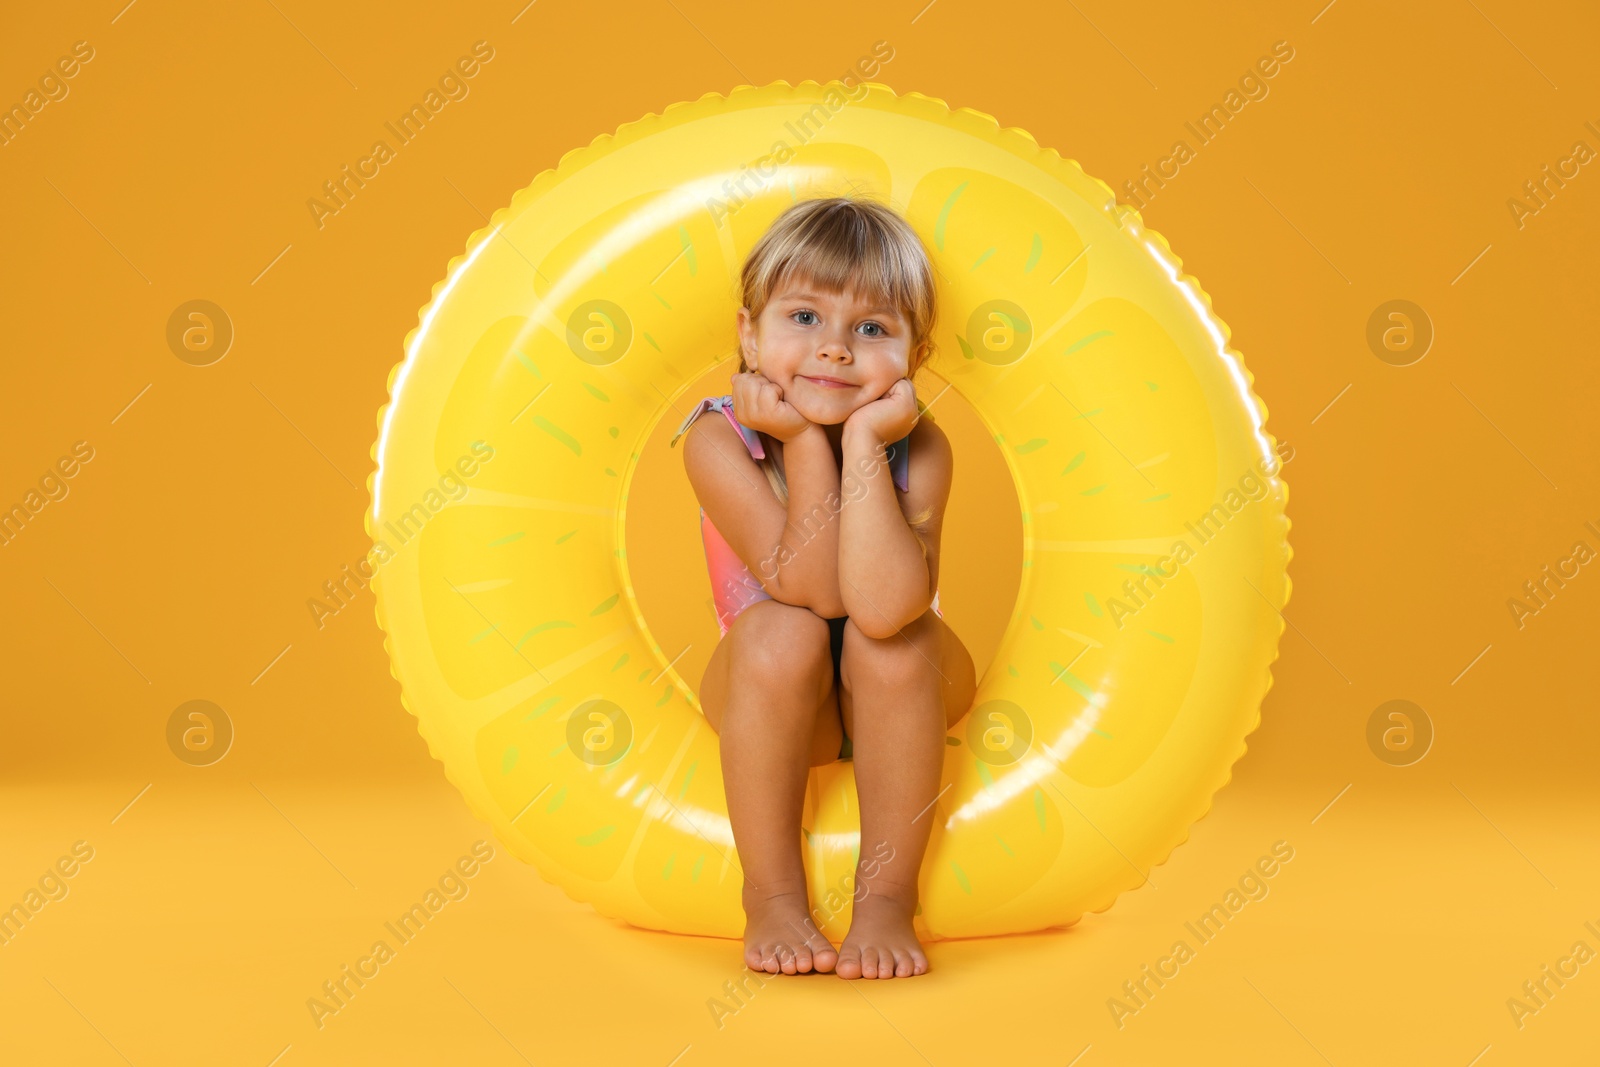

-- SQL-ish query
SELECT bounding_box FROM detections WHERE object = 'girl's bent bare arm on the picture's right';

[838,419,955,638]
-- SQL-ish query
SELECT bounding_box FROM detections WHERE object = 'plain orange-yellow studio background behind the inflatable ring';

[0,0,1600,1067]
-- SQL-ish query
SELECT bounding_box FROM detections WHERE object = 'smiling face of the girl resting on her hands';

[739,278,912,426]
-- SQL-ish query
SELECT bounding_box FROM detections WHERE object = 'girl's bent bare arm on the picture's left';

[683,419,845,619]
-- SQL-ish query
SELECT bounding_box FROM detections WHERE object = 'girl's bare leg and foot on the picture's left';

[701,600,842,974]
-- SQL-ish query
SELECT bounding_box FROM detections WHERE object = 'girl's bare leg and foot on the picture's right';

[837,608,978,977]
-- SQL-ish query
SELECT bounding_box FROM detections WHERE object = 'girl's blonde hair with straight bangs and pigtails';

[739,197,938,537]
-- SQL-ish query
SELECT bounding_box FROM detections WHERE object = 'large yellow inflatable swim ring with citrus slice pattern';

[366,82,1291,941]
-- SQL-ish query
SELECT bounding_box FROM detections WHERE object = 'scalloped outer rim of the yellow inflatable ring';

[362,78,1294,941]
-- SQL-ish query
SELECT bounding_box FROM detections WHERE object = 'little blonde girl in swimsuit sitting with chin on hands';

[672,198,976,977]
